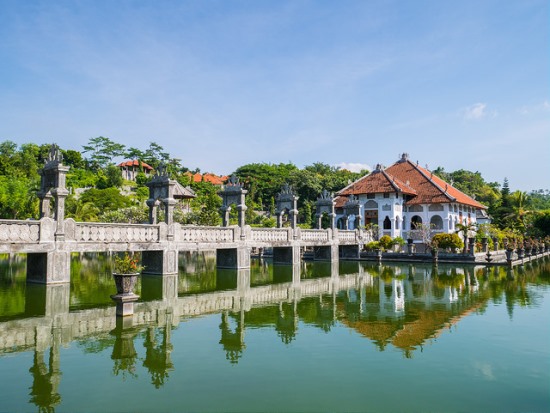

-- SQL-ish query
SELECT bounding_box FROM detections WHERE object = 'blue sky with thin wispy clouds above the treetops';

[0,0,550,191]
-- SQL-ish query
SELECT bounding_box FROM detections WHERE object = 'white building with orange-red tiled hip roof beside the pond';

[336,154,486,239]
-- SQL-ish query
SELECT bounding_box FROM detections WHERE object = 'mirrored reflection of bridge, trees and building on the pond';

[0,256,550,411]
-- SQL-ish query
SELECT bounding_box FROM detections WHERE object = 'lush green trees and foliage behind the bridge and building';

[0,136,550,235]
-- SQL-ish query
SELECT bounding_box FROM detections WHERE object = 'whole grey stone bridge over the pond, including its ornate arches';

[0,145,366,284]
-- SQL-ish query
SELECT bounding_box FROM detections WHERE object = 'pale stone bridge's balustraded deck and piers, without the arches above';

[0,217,364,284]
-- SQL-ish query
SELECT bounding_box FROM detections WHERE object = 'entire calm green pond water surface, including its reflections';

[0,254,550,412]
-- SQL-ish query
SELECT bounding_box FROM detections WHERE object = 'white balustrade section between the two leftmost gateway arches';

[74,222,160,242]
